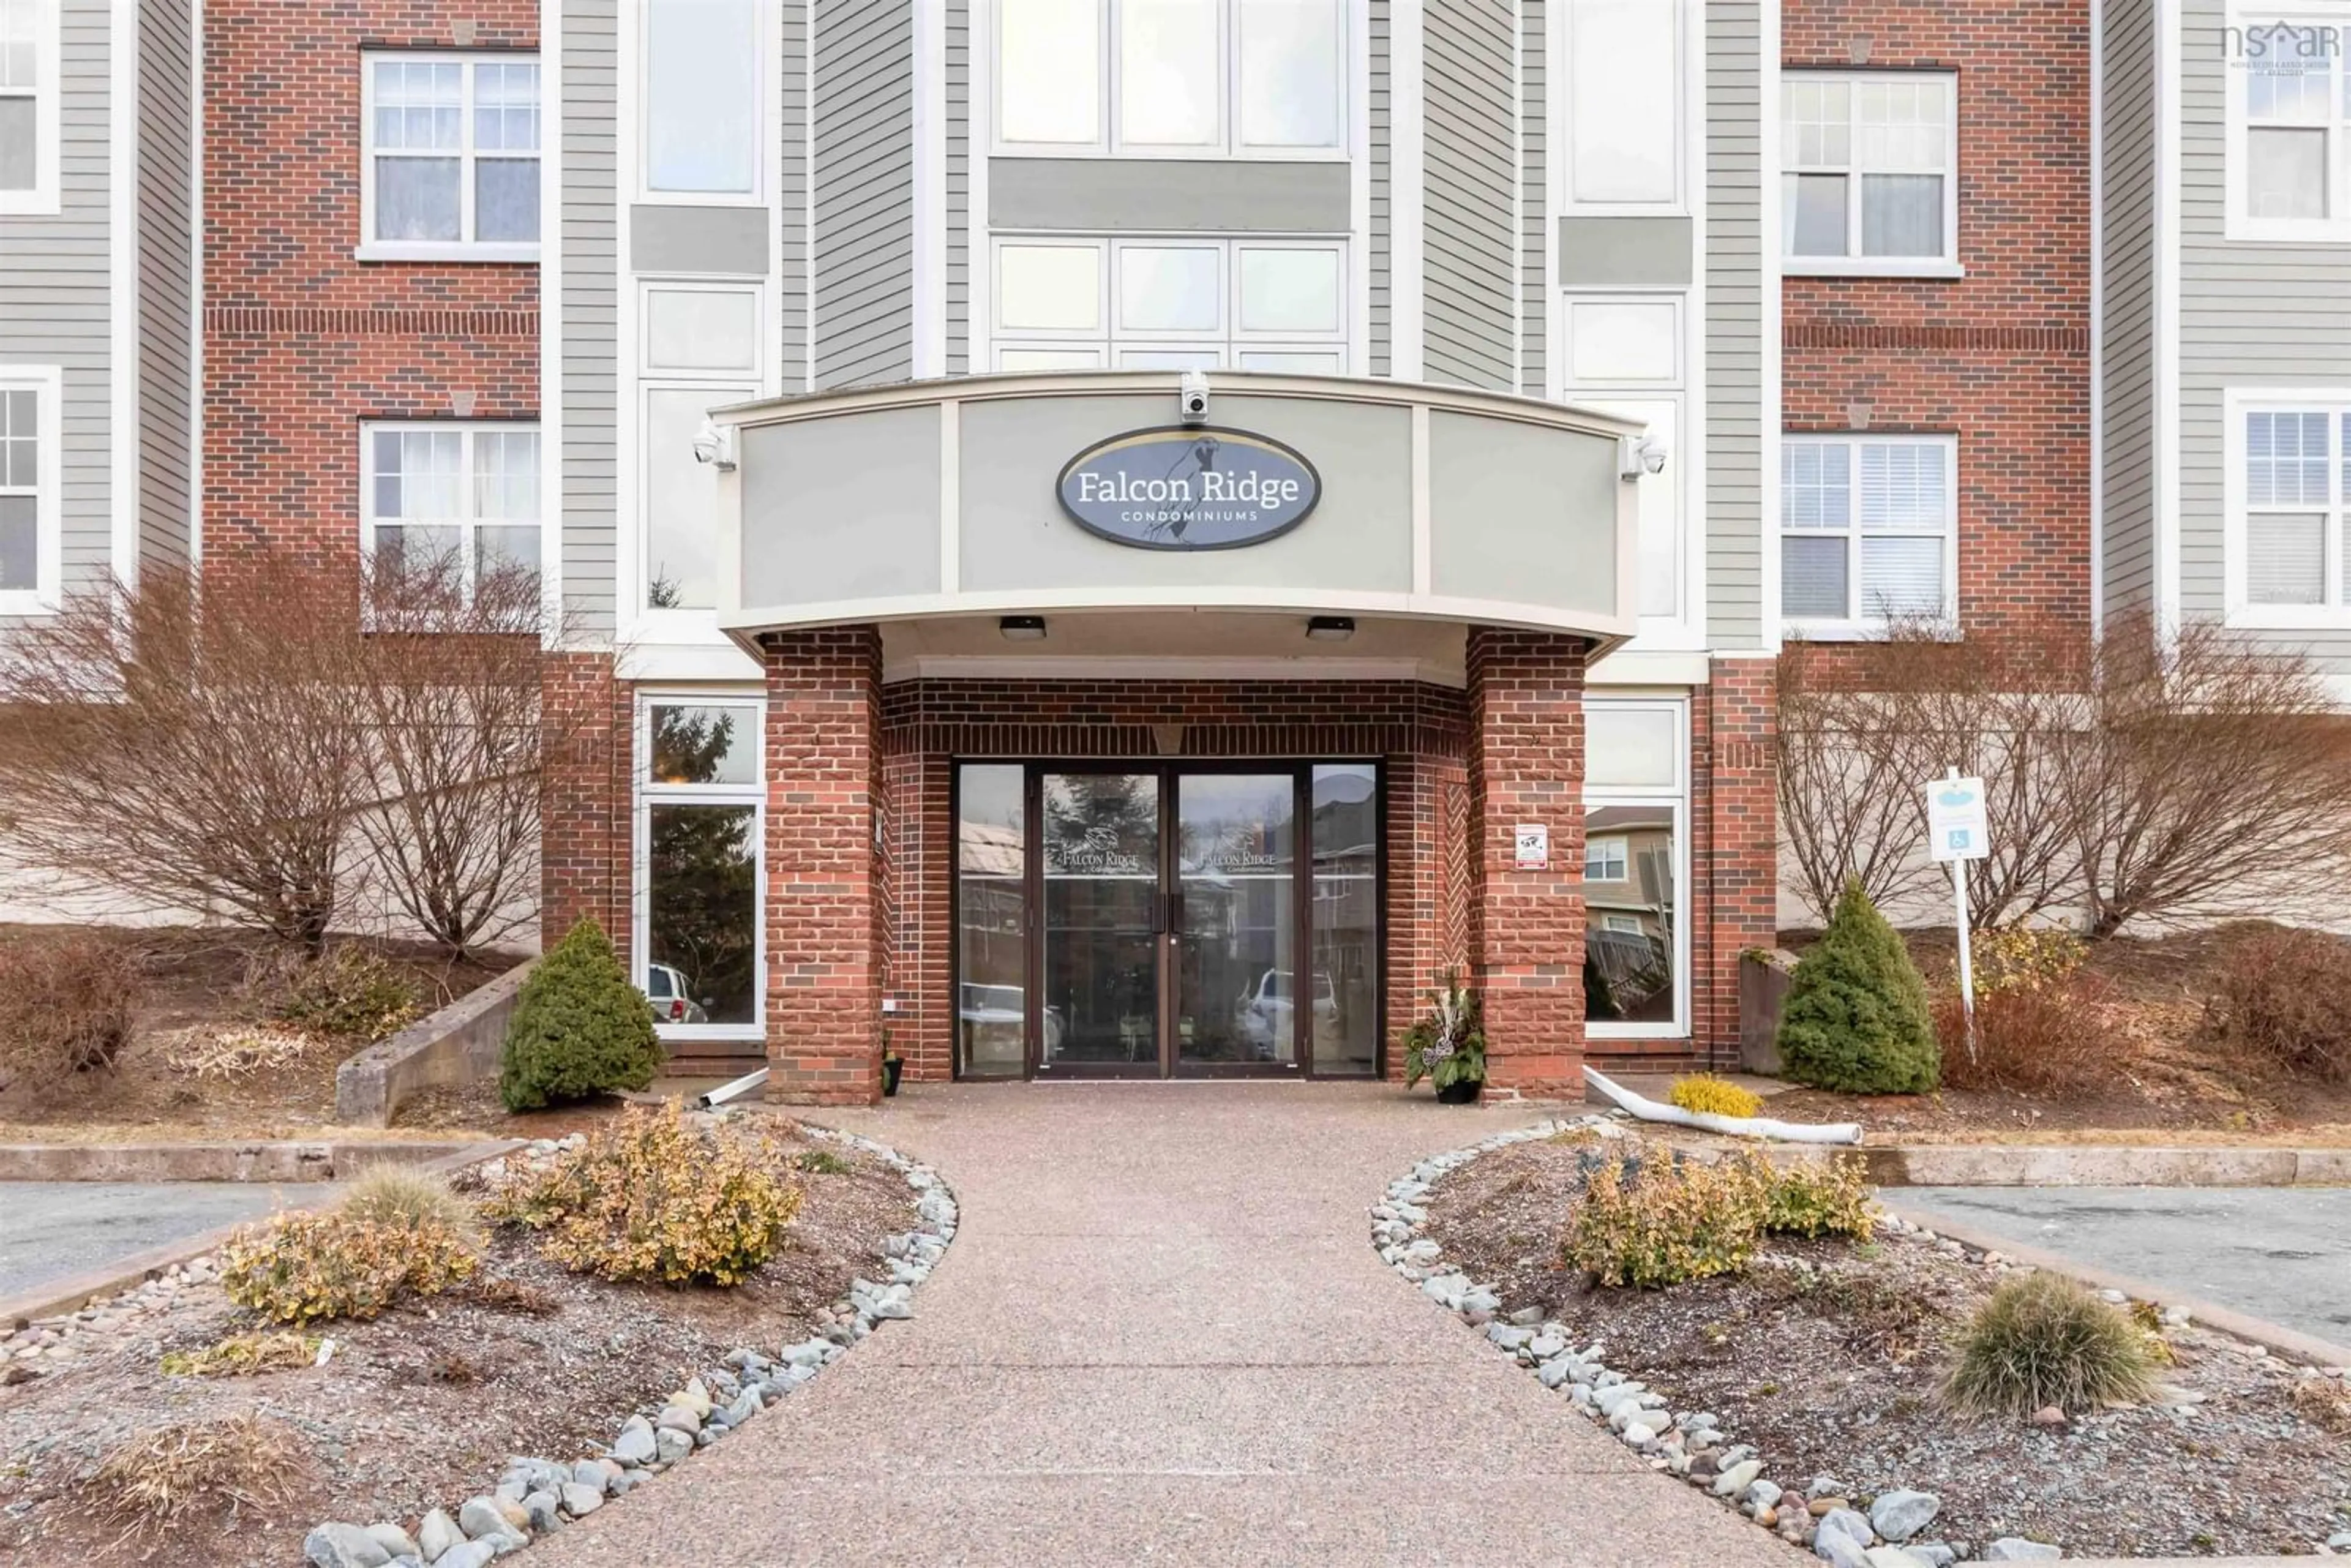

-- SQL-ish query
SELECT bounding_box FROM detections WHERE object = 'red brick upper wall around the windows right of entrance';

[1780,0,2090,632]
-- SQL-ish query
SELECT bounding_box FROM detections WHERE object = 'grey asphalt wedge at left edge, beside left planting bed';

[0,1182,294,1297]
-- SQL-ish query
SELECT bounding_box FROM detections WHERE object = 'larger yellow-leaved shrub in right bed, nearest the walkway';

[1561,1154,1763,1291]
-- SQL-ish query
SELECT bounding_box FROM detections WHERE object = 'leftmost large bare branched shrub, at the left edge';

[0,555,367,952]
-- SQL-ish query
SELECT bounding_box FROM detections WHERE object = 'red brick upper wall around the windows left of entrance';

[202,0,538,566]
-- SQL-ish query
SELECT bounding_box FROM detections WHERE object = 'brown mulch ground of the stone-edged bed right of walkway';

[1425,1133,2351,1556]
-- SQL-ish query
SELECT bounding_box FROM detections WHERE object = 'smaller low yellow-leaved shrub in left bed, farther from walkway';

[221,1210,479,1324]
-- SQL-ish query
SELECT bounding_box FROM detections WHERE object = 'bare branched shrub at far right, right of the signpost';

[2050,618,2351,938]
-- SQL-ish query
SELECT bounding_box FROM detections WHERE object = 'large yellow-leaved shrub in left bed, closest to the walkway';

[489,1105,801,1286]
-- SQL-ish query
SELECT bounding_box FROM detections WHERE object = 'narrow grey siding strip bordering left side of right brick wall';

[1704,0,1763,649]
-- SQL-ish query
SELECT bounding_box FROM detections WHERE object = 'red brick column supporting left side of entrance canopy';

[762,625,882,1105]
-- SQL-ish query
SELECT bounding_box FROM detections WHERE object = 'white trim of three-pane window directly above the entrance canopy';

[976,233,1357,373]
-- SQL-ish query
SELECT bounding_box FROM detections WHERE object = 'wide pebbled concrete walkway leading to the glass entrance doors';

[531,1084,1777,1568]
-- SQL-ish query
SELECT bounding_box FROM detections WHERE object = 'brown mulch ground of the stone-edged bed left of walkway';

[0,1117,917,1568]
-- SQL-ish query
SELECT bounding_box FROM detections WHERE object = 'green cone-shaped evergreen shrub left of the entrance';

[498,919,661,1109]
